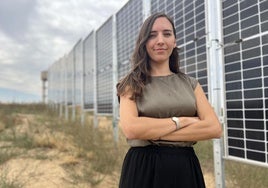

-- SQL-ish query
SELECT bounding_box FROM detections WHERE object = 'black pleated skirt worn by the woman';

[119,145,205,188]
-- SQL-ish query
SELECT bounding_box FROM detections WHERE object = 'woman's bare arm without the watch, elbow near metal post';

[161,84,222,141]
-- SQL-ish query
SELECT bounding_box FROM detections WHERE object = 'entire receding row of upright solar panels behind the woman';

[48,0,268,165]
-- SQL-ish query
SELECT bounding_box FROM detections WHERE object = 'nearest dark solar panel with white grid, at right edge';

[222,0,268,164]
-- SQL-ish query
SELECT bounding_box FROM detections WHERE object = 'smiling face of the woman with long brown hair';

[146,17,176,63]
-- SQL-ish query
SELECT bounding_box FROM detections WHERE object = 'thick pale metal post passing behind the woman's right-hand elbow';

[206,0,225,188]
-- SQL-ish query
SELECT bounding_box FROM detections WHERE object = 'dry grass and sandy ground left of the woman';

[0,104,126,188]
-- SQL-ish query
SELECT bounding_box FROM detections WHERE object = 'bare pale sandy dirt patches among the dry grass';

[0,114,215,188]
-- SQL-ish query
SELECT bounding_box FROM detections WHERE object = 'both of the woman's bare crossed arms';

[120,84,222,141]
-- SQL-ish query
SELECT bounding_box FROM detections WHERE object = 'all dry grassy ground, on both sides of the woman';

[0,104,268,188]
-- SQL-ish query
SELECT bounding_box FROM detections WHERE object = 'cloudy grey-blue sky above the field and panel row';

[0,0,128,102]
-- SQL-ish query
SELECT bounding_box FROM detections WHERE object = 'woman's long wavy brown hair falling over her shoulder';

[116,13,180,100]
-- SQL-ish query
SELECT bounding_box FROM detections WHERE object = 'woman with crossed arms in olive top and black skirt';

[117,13,222,188]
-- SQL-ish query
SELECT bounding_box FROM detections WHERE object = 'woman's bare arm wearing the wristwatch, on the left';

[120,91,195,140]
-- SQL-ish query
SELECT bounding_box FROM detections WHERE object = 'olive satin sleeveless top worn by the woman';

[127,73,198,147]
